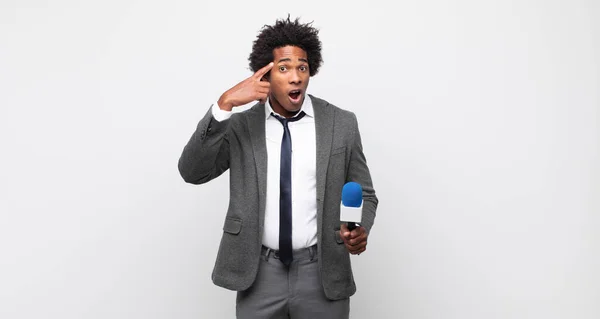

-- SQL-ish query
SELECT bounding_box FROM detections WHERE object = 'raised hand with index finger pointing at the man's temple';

[218,62,274,111]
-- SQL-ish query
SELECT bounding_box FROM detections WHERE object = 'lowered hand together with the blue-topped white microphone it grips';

[340,182,368,255]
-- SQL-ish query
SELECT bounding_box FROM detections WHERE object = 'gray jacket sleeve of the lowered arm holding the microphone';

[346,113,379,233]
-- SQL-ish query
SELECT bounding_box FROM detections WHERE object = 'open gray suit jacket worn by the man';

[179,95,378,300]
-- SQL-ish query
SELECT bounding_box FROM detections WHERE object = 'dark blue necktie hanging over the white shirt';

[271,111,305,266]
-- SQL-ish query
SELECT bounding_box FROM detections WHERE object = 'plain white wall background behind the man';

[0,0,600,319]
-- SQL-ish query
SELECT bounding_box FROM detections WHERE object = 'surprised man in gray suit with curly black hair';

[179,16,378,318]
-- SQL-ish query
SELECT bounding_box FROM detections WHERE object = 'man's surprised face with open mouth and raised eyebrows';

[268,45,310,117]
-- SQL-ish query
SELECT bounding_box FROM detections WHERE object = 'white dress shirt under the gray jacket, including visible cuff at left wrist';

[212,95,317,250]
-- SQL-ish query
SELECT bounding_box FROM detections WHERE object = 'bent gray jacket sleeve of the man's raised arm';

[178,106,231,184]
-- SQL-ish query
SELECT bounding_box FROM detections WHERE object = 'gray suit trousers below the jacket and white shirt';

[236,245,350,319]
